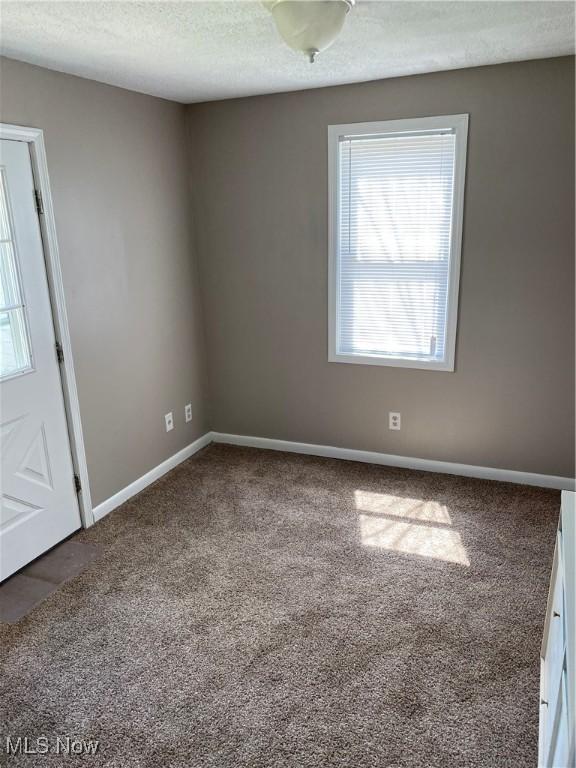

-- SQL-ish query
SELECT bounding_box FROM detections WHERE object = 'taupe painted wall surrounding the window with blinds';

[188,58,574,475]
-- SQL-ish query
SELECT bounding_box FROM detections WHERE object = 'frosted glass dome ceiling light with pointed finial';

[264,0,354,63]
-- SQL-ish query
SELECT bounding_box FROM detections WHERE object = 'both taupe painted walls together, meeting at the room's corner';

[0,58,574,504]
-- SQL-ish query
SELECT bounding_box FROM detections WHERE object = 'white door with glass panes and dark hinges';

[0,139,80,580]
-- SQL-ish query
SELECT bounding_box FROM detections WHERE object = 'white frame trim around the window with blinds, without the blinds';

[328,114,468,371]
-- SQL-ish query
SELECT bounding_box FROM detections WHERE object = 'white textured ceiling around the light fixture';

[1,0,574,102]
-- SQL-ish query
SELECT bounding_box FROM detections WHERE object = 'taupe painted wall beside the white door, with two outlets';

[0,59,209,504]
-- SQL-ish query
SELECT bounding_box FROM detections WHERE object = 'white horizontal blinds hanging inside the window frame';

[336,130,455,360]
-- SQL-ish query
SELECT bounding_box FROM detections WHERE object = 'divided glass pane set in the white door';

[0,168,32,378]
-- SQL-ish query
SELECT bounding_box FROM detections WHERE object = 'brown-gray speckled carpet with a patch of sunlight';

[0,446,560,768]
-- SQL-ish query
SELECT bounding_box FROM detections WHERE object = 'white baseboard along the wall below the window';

[212,432,576,491]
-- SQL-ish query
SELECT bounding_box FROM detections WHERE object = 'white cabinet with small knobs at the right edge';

[538,491,576,768]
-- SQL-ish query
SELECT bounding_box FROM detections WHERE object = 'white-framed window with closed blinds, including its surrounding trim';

[329,115,468,371]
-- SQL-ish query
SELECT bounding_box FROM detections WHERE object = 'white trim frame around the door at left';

[0,123,95,528]
